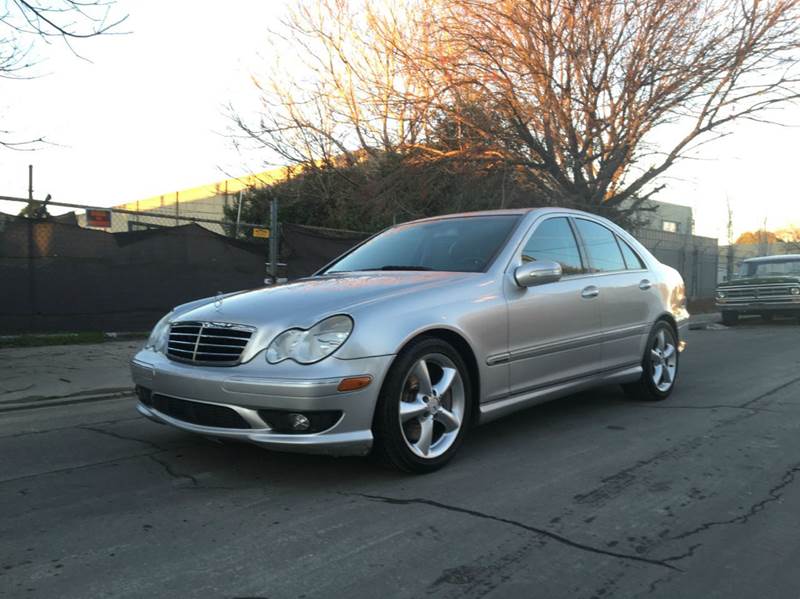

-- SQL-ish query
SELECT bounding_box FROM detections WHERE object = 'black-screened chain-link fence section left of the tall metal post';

[0,197,271,334]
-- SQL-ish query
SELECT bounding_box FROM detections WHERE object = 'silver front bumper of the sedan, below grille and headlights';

[131,349,394,455]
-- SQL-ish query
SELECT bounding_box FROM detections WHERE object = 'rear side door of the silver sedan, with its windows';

[574,218,656,369]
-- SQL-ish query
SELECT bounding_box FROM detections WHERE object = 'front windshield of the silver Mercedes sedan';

[325,214,519,273]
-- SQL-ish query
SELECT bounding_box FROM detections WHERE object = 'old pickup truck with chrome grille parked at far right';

[717,254,800,326]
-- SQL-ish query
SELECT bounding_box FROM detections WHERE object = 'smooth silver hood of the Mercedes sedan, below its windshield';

[175,272,471,332]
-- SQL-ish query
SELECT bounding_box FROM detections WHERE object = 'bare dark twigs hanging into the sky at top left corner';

[0,0,127,149]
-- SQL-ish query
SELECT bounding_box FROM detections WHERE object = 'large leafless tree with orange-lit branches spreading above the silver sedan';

[237,0,800,223]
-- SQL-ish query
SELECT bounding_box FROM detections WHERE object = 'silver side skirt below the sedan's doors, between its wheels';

[479,364,642,424]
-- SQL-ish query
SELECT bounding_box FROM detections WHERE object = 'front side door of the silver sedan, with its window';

[506,216,602,395]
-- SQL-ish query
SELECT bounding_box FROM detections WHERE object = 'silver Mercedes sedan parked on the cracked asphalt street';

[132,208,689,472]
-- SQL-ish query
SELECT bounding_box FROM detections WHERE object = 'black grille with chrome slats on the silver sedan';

[167,322,255,366]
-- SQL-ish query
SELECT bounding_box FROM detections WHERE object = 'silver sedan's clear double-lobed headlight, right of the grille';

[267,314,353,364]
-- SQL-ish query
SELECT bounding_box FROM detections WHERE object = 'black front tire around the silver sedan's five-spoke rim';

[372,337,474,474]
